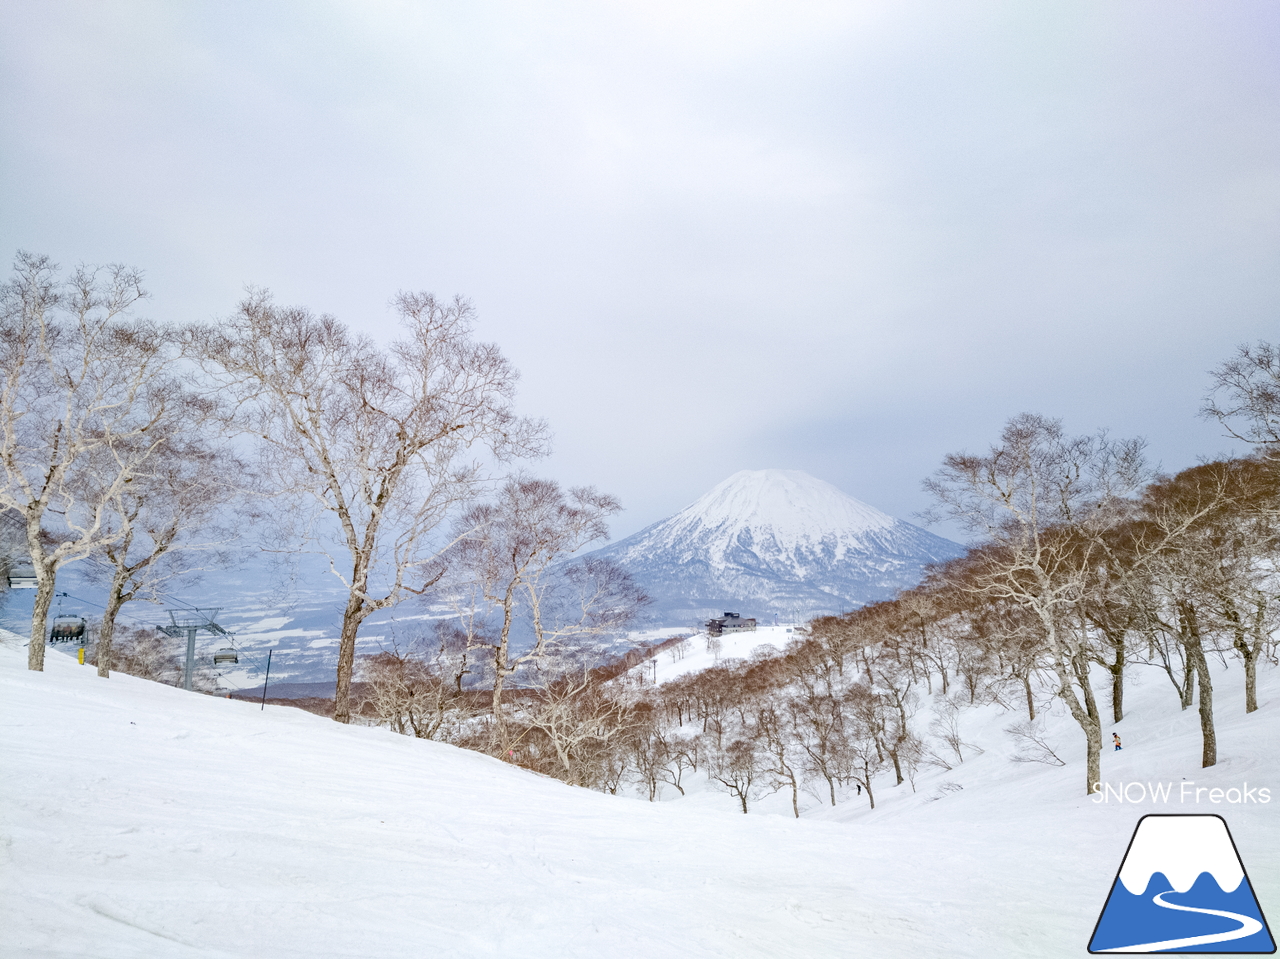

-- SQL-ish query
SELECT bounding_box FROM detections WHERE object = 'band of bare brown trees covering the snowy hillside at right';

[366,343,1280,798]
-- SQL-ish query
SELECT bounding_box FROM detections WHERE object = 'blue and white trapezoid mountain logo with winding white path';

[1089,816,1276,954]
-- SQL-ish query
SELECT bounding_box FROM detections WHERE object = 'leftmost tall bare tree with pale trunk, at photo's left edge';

[0,252,196,670]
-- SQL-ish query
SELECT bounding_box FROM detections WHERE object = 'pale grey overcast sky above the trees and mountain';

[0,0,1280,535]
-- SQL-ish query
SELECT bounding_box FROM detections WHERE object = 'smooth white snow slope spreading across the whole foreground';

[0,632,1280,959]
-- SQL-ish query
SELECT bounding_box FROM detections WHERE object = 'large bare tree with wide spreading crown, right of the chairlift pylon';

[191,291,545,722]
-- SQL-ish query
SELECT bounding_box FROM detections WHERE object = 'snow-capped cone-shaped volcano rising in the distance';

[594,470,964,625]
